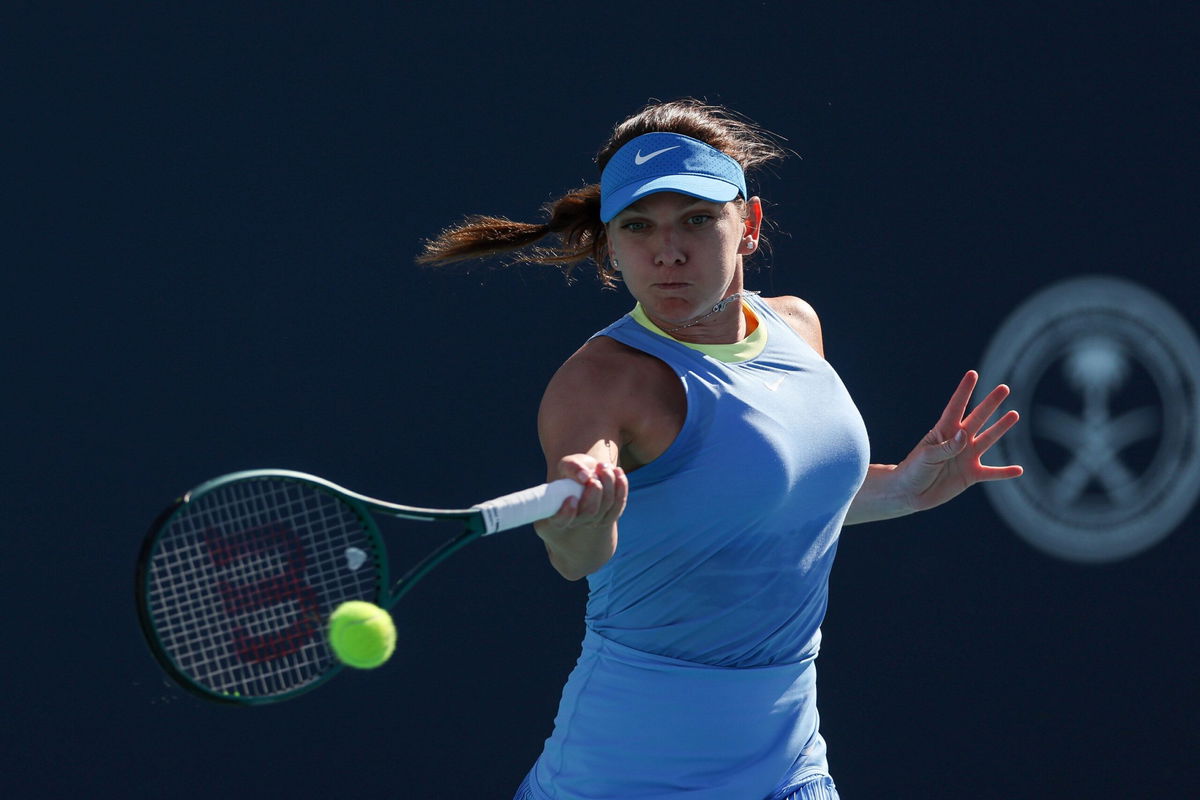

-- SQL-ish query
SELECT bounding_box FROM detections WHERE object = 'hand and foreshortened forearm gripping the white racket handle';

[534,453,629,581]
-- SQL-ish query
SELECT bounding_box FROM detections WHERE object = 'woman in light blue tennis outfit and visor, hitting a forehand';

[422,101,1021,800]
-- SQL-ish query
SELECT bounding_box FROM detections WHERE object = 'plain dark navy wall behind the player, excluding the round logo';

[7,0,1200,799]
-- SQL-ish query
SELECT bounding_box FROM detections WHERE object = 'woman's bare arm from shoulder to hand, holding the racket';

[534,338,631,581]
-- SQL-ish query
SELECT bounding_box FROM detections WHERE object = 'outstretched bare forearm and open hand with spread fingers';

[845,371,1022,525]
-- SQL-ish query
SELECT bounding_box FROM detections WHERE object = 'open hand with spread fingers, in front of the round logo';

[889,371,1024,511]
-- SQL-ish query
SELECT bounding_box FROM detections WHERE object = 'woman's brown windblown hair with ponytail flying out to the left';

[416,100,786,287]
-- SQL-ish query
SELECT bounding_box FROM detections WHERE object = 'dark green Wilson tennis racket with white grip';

[136,469,582,705]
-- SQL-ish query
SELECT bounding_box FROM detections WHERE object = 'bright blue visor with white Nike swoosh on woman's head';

[600,133,749,222]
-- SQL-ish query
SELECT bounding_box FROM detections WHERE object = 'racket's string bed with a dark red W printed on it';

[148,479,380,698]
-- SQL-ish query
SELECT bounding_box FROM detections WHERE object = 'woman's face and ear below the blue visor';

[608,192,762,330]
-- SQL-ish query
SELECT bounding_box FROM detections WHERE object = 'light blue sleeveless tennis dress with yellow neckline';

[517,296,869,800]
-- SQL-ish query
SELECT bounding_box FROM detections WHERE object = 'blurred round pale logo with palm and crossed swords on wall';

[979,276,1200,563]
